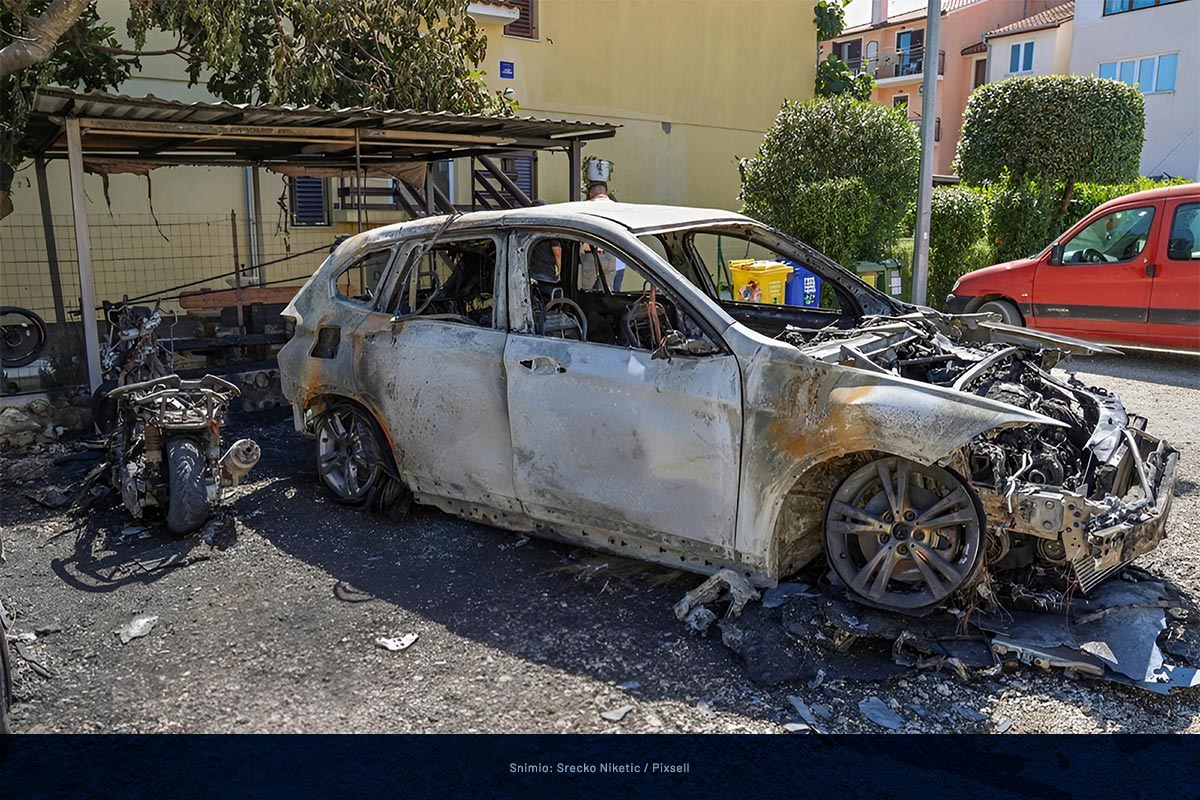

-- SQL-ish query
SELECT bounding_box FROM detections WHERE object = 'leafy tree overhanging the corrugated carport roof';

[0,0,511,217]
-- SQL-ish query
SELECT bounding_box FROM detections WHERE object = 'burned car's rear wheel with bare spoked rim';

[317,404,383,505]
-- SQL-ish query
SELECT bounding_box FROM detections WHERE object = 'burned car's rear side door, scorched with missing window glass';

[354,233,520,511]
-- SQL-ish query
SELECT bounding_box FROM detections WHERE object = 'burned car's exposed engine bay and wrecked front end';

[779,314,1178,593]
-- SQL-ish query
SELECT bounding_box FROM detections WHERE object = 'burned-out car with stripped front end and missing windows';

[280,201,1178,613]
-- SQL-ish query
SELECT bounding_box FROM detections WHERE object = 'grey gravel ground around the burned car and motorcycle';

[0,353,1200,733]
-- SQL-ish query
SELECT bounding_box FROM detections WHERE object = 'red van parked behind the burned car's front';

[946,184,1200,350]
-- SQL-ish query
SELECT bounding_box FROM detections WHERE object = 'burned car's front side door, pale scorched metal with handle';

[504,231,742,558]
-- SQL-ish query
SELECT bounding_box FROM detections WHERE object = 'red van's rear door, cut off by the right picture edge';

[1147,197,1200,350]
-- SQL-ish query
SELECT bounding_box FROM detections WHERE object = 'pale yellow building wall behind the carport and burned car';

[0,0,816,321]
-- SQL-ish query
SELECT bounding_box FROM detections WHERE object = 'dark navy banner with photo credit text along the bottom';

[0,735,1200,800]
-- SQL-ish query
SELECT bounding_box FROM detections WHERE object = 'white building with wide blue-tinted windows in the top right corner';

[1058,0,1200,180]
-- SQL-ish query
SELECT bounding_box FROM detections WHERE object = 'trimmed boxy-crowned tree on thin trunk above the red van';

[955,76,1146,215]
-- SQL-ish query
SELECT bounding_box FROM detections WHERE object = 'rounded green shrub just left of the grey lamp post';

[742,97,920,261]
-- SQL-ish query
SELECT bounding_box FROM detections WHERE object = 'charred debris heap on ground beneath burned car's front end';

[700,567,1200,695]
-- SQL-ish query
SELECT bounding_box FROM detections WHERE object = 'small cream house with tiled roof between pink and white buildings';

[983,0,1086,83]
